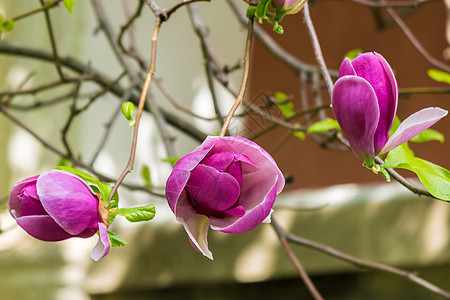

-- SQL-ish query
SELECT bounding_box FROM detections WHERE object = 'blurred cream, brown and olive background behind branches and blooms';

[0,0,450,299]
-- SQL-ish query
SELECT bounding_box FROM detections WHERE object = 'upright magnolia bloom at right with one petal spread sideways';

[331,52,447,167]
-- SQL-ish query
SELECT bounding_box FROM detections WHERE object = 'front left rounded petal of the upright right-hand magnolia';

[331,76,380,158]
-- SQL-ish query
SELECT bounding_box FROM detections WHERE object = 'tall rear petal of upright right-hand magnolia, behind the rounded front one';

[352,52,398,153]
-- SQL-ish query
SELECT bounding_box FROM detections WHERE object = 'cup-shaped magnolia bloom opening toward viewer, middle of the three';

[166,136,284,259]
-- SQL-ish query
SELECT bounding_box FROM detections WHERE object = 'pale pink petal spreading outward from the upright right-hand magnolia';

[380,107,448,154]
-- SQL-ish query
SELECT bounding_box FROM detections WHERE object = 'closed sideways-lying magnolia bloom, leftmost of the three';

[9,170,110,261]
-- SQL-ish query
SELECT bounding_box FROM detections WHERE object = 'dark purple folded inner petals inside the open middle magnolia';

[186,164,240,215]
